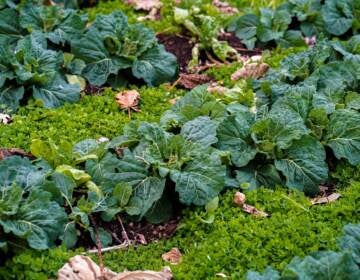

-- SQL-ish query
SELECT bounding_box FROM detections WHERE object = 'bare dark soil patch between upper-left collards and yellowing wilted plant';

[157,34,194,73]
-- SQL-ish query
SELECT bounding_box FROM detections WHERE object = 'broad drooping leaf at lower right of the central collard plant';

[170,150,226,205]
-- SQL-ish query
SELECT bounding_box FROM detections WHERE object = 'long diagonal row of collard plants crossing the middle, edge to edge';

[0,32,360,254]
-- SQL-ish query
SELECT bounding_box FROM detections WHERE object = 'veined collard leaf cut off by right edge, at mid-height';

[325,109,360,165]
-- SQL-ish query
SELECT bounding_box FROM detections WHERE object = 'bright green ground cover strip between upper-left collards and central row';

[0,87,182,150]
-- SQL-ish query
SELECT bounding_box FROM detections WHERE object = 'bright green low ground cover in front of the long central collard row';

[0,180,360,279]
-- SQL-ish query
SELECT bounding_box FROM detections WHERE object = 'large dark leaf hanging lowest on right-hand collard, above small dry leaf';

[275,136,328,194]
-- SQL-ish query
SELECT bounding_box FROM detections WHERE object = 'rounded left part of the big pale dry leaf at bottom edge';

[58,256,117,280]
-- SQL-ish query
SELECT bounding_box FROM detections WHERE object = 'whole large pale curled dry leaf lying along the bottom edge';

[58,256,172,280]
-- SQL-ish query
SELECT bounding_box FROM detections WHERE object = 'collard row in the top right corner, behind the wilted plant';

[228,0,360,49]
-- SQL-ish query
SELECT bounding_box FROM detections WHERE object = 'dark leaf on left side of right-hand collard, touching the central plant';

[217,112,257,167]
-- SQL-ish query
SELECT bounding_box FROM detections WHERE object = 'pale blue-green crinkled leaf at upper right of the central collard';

[180,117,218,147]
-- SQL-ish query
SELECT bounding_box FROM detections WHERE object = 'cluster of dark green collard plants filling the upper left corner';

[0,1,178,110]
